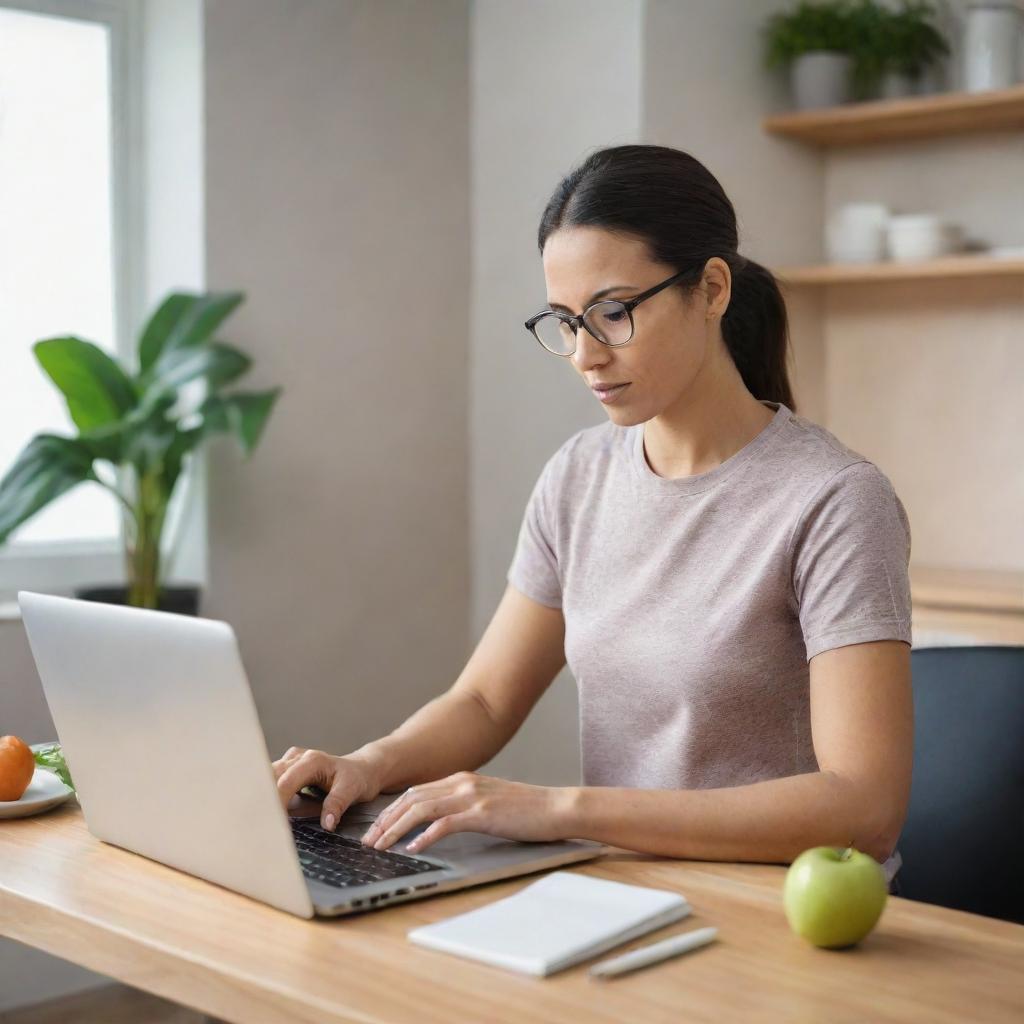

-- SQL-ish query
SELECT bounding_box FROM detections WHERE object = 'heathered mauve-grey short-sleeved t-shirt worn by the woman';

[507,401,911,874]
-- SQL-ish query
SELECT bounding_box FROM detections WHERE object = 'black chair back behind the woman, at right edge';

[892,646,1024,924]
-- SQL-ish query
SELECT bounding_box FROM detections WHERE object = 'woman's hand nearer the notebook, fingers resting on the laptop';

[362,771,573,852]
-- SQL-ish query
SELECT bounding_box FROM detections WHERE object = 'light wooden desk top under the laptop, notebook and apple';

[0,799,1024,1024]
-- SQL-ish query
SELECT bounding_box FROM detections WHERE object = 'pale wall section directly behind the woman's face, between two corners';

[469,0,643,785]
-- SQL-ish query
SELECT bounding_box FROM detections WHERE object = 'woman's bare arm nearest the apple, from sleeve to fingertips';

[364,640,913,864]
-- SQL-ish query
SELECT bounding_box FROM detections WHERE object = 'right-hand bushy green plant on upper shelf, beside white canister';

[852,0,950,99]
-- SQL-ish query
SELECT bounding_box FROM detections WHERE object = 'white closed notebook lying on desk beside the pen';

[408,871,691,976]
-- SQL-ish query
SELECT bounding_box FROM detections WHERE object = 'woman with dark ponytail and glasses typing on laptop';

[274,145,913,882]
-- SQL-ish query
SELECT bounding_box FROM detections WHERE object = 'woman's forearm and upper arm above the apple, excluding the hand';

[560,640,913,863]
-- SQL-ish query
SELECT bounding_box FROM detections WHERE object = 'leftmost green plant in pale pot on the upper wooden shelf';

[764,0,857,110]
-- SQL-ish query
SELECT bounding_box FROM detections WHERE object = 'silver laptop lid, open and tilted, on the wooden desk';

[17,591,313,918]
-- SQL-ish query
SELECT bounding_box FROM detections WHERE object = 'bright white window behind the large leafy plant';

[0,0,141,593]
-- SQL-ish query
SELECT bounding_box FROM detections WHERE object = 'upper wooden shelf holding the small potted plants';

[762,83,1024,146]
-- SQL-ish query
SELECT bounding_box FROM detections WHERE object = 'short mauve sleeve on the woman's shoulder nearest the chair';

[792,462,912,662]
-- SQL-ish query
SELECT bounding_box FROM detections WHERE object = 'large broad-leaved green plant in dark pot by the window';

[0,292,281,614]
